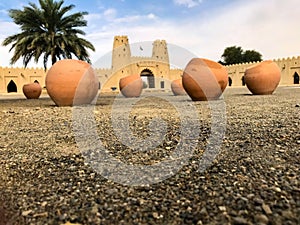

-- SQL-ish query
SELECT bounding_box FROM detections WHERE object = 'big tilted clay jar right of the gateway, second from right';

[182,58,228,101]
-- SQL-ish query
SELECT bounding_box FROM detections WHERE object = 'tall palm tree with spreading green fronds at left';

[2,0,95,70]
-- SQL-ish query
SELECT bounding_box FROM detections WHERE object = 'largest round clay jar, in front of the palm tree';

[46,59,99,106]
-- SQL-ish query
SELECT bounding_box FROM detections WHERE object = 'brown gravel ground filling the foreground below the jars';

[0,87,300,225]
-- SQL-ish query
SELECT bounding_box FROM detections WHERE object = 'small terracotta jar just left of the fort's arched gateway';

[119,75,143,98]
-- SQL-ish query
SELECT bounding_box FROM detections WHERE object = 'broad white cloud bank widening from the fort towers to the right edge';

[93,0,300,65]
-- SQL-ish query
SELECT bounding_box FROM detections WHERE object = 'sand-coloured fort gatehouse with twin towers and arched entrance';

[96,36,182,92]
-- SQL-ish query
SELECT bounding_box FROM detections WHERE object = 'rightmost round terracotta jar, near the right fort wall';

[244,60,281,95]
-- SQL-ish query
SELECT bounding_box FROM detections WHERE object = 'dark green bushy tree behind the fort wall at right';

[219,46,262,65]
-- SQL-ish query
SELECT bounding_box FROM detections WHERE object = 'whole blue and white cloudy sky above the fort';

[0,0,300,67]
